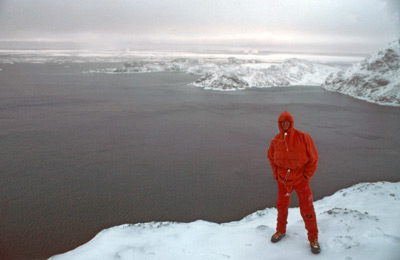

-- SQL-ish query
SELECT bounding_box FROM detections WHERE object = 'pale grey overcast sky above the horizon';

[0,0,400,52]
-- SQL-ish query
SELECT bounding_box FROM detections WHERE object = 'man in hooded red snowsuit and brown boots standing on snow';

[268,111,321,253]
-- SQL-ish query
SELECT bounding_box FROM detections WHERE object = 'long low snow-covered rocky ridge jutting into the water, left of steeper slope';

[87,57,342,91]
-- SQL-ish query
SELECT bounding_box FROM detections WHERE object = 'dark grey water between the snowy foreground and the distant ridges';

[0,64,400,259]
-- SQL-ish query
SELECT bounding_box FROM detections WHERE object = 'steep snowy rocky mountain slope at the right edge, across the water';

[323,38,400,105]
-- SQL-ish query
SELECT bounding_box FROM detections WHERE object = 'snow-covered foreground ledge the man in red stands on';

[50,182,400,260]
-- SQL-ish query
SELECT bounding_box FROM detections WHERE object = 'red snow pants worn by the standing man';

[276,179,318,241]
